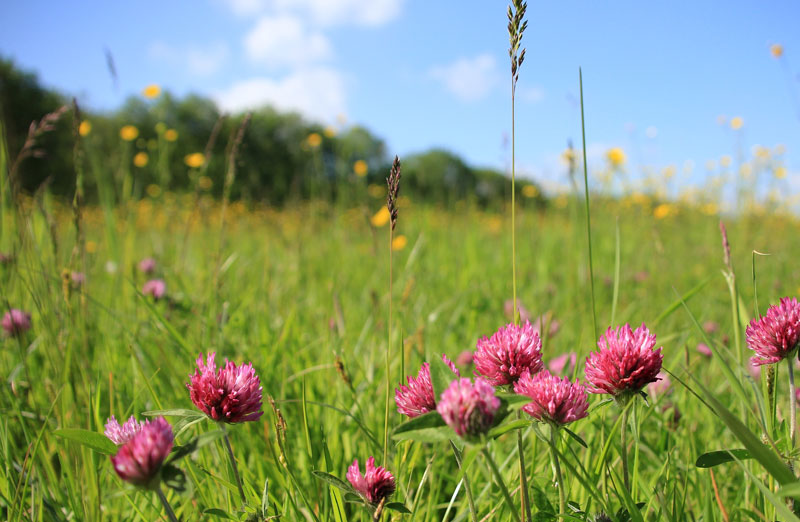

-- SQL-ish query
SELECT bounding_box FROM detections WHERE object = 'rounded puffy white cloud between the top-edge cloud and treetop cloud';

[244,15,333,67]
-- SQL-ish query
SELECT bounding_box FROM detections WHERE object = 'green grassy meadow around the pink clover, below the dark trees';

[0,184,800,521]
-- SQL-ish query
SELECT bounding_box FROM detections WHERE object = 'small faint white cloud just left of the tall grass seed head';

[430,53,499,102]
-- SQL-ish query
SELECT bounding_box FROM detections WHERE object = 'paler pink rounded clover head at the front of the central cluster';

[436,377,500,439]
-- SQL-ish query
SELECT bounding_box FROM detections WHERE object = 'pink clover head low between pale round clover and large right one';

[514,370,589,426]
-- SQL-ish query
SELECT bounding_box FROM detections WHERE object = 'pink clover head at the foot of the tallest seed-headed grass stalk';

[475,321,542,386]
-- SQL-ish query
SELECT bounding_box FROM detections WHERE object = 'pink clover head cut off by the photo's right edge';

[745,297,800,366]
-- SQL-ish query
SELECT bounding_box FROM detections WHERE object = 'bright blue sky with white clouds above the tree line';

[0,0,800,191]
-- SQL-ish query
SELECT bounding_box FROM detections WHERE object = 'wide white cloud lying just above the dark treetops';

[213,67,347,122]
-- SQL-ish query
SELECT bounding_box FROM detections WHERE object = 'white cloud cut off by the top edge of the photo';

[224,0,405,27]
